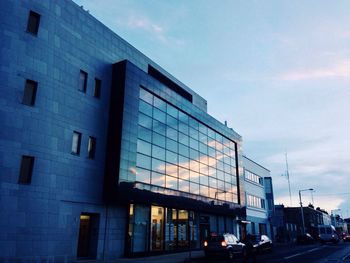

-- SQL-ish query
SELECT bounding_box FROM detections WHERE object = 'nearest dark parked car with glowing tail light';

[203,233,247,259]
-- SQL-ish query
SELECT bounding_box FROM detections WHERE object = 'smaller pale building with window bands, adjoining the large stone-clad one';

[243,156,274,238]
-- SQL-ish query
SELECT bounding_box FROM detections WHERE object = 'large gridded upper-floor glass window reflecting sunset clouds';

[136,88,238,203]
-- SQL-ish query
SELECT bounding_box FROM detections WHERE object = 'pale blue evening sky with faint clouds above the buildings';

[74,0,350,217]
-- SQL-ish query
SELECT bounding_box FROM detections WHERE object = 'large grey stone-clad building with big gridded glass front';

[0,0,246,262]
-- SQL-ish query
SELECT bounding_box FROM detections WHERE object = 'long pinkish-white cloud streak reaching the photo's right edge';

[278,60,350,81]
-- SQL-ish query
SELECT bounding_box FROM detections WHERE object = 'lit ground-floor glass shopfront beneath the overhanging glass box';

[126,204,199,254]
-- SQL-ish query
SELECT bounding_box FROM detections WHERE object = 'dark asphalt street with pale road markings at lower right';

[191,242,350,263]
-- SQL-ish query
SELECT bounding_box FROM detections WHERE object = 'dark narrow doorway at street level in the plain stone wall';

[77,213,99,259]
